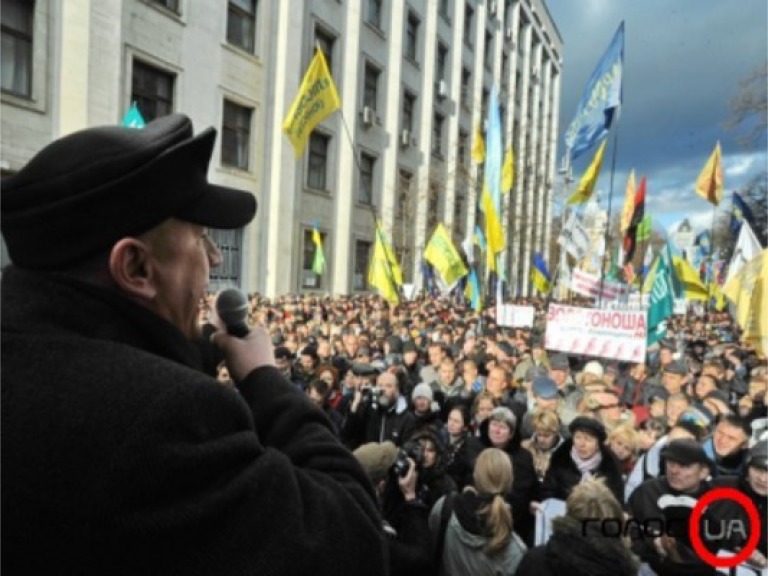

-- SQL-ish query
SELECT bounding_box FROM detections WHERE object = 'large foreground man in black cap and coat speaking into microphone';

[0,115,386,575]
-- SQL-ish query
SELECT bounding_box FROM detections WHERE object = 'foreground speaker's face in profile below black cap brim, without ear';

[138,219,221,340]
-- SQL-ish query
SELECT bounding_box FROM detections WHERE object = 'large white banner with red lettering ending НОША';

[546,304,647,362]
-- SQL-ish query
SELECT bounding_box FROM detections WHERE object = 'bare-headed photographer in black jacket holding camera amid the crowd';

[342,367,416,450]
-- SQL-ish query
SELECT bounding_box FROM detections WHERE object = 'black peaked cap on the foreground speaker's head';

[1,114,256,270]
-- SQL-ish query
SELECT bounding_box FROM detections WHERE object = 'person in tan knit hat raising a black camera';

[354,441,435,576]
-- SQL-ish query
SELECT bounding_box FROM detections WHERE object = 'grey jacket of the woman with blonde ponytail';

[429,492,526,576]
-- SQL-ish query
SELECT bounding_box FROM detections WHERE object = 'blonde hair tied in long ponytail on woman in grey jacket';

[473,448,513,554]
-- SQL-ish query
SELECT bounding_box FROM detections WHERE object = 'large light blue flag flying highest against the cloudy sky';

[565,22,624,160]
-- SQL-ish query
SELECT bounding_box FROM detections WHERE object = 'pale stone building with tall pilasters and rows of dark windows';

[1,0,562,296]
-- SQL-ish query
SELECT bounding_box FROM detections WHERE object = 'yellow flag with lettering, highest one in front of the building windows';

[283,48,341,158]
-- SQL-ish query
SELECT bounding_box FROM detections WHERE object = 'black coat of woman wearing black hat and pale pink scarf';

[540,438,624,502]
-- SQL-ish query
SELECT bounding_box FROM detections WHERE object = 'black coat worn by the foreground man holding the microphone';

[0,268,387,576]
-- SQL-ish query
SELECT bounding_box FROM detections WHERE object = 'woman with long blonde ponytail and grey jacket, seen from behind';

[429,448,526,576]
